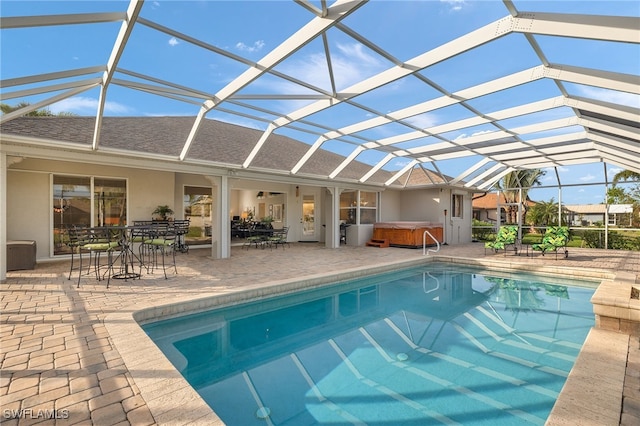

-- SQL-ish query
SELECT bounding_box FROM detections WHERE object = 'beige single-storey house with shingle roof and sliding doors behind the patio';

[0,116,478,272]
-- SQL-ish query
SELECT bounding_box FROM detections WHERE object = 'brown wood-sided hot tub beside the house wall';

[373,221,444,248]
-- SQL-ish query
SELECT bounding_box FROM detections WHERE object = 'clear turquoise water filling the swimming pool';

[143,264,595,426]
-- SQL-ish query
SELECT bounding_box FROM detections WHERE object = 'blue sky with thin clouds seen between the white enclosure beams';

[0,0,640,203]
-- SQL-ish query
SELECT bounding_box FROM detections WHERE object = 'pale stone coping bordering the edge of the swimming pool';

[104,255,629,425]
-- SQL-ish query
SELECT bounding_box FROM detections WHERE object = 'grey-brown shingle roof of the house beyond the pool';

[0,116,430,185]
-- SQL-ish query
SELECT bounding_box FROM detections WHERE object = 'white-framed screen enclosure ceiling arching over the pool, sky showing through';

[0,0,640,189]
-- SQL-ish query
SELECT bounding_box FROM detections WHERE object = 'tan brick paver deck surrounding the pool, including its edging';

[0,243,640,426]
